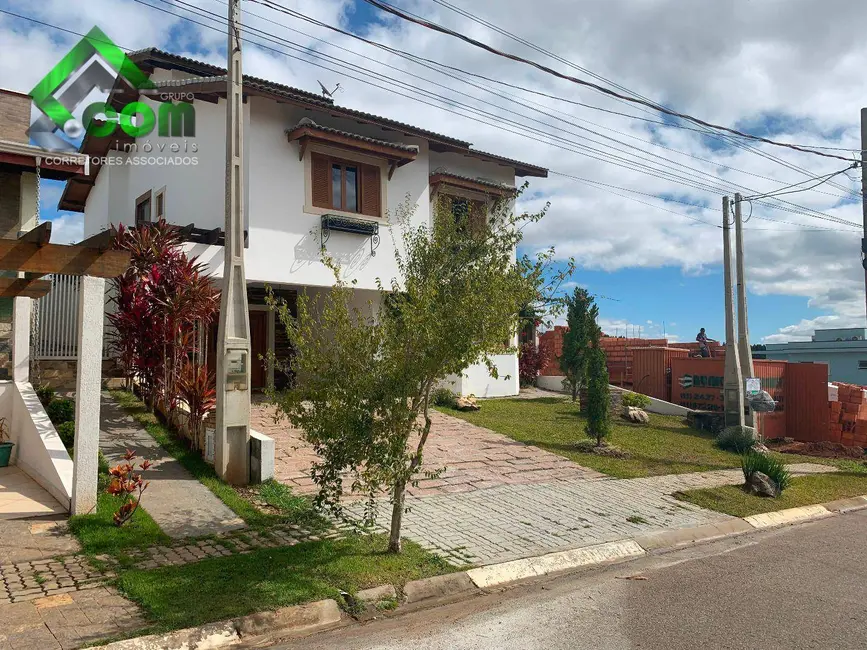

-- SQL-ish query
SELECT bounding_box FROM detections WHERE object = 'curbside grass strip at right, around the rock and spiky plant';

[674,467,867,517]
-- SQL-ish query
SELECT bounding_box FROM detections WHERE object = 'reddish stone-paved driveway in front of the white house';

[251,403,603,496]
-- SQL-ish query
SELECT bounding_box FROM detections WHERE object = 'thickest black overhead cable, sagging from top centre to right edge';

[364,0,849,162]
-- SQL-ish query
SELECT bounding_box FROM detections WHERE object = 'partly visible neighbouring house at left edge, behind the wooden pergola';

[0,88,85,379]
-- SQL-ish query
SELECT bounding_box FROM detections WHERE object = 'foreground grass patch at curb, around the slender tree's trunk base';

[118,536,457,632]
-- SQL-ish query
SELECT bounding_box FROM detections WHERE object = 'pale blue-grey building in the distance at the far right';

[761,327,867,386]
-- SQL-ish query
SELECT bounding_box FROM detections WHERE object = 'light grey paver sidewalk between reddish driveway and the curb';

[352,463,835,564]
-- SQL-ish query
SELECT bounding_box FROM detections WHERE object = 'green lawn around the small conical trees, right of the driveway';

[442,397,744,478]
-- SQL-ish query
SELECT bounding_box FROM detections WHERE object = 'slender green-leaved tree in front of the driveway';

[270,189,562,552]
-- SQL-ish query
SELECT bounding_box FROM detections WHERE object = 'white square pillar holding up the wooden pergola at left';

[72,276,105,515]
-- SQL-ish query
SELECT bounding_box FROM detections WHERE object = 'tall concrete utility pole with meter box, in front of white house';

[214,0,252,485]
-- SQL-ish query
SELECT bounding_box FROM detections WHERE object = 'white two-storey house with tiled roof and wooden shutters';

[60,49,547,396]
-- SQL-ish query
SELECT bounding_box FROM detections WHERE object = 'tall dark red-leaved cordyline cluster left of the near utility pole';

[108,220,219,444]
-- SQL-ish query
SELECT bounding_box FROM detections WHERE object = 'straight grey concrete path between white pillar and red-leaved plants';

[99,394,244,538]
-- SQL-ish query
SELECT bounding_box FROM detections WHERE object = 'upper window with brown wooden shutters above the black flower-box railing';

[310,152,382,217]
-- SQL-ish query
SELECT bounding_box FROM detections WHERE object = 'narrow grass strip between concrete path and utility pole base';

[111,390,325,529]
